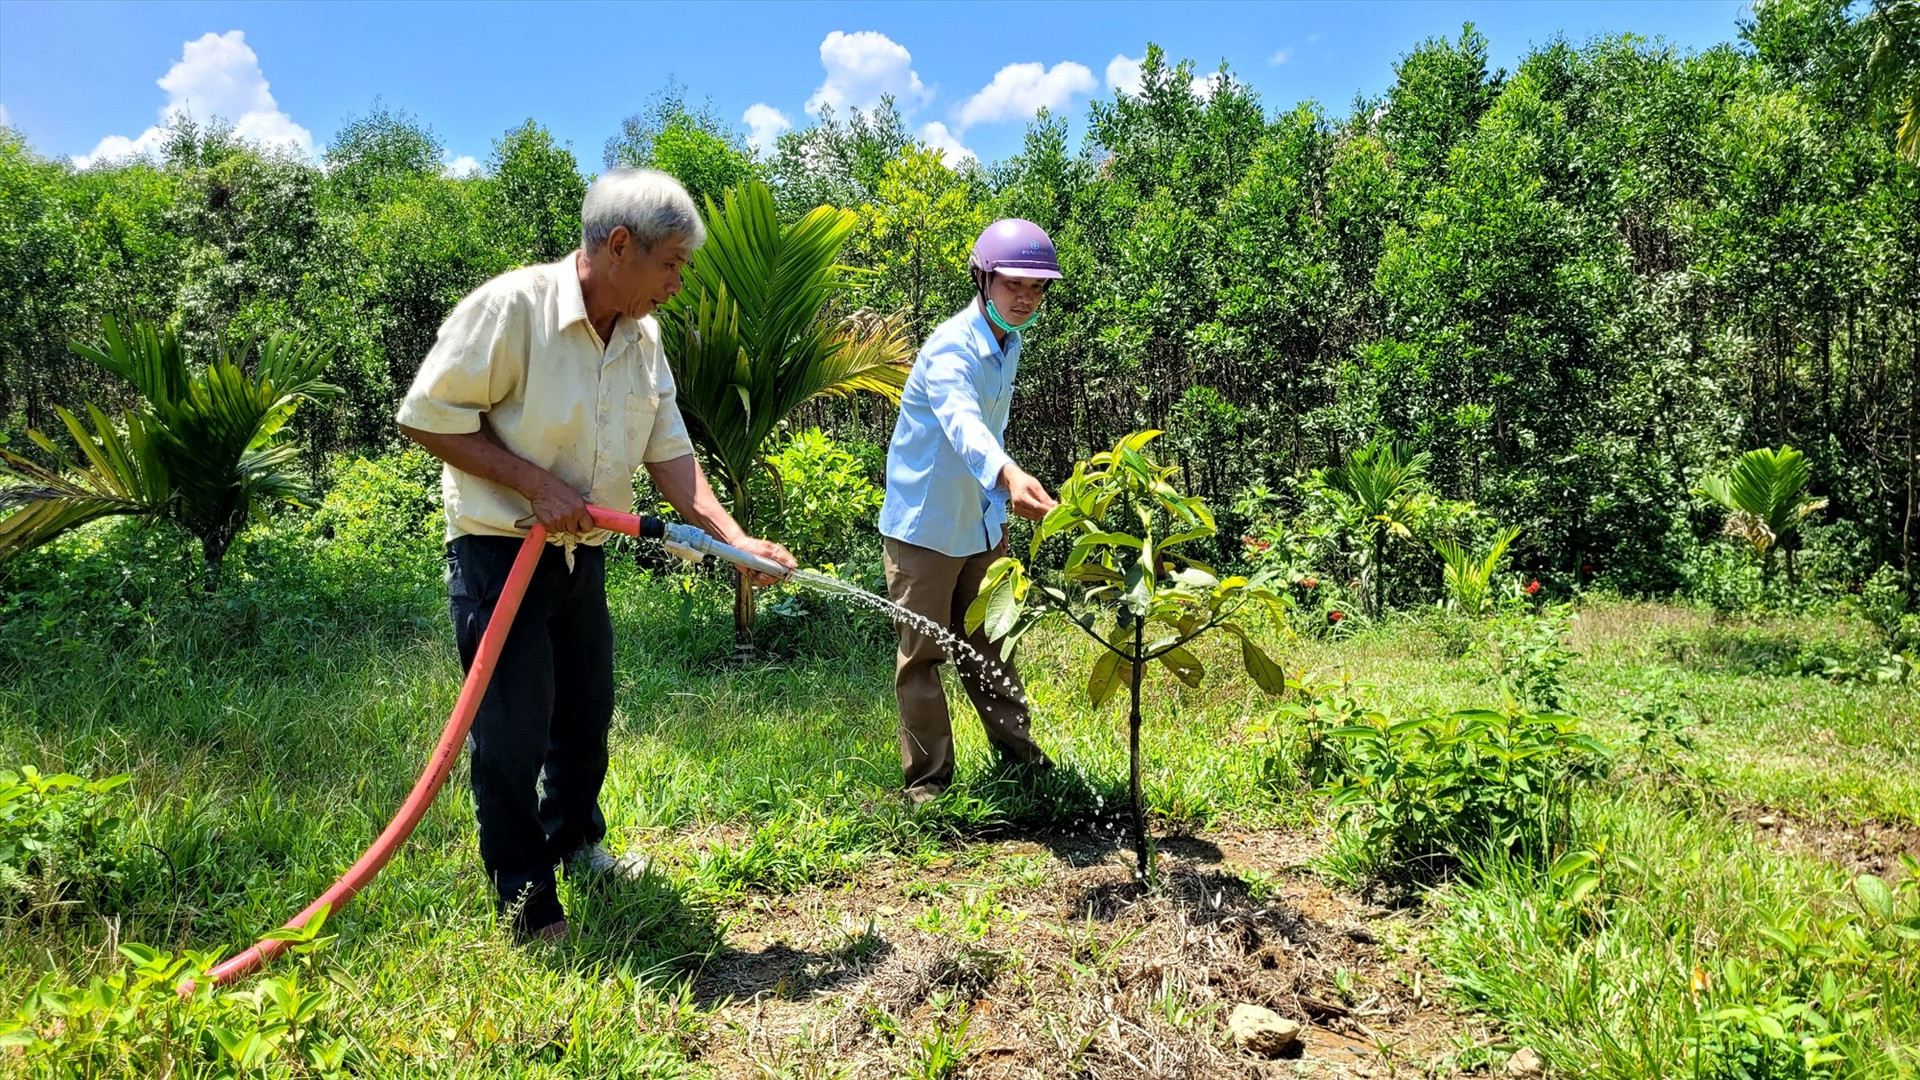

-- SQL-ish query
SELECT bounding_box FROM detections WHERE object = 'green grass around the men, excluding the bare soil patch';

[0,518,1920,1076]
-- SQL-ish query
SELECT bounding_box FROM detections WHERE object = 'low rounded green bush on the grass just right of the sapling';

[1323,707,1609,880]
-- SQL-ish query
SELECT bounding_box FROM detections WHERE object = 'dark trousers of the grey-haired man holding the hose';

[447,536,612,930]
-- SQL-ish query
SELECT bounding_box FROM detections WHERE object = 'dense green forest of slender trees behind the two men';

[0,0,1920,594]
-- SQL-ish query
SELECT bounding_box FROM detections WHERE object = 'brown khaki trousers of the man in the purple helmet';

[885,536,1046,792]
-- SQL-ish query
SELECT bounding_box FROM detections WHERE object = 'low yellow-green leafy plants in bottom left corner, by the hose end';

[0,911,349,1080]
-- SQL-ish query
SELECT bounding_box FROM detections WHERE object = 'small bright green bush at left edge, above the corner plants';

[0,765,131,911]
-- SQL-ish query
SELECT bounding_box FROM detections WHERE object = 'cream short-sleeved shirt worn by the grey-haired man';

[396,252,693,544]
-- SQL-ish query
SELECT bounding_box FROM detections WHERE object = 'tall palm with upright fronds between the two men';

[660,181,914,644]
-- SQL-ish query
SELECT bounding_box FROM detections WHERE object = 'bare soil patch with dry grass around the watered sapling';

[668,818,1498,1080]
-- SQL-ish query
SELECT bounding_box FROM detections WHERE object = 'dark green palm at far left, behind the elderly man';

[0,319,338,590]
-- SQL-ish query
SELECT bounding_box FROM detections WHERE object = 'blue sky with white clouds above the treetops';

[0,0,1747,171]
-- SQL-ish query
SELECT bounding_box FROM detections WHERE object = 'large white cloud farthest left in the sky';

[73,31,313,169]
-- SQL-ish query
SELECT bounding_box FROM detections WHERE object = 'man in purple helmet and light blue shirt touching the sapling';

[879,219,1060,805]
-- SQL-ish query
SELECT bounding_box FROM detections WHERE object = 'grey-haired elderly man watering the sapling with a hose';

[397,169,793,940]
